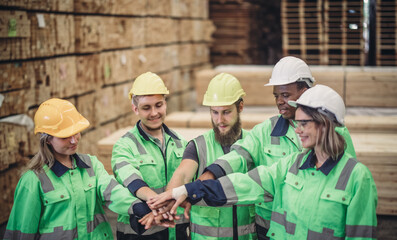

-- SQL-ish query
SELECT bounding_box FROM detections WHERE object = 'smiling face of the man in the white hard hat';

[273,83,306,120]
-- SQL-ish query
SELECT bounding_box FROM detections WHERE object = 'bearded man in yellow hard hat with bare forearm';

[142,73,256,240]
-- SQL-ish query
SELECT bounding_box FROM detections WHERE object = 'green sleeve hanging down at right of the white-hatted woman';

[346,163,378,239]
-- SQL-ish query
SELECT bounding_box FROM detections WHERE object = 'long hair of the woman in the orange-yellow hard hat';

[27,133,55,172]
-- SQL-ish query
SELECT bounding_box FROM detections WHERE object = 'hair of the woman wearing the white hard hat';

[298,105,346,160]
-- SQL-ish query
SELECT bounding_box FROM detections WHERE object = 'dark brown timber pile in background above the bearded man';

[209,0,265,66]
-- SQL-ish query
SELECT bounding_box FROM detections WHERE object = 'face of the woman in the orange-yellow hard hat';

[48,133,81,160]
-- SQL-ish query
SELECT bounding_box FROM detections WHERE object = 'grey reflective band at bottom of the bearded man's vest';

[190,223,255,238]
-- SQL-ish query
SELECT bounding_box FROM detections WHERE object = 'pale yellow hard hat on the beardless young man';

[129,72,169,99]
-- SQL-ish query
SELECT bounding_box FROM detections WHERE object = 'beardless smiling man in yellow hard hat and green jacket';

[112,72,189,239]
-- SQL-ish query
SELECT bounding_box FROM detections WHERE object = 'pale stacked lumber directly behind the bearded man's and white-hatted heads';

[195,65,397,107]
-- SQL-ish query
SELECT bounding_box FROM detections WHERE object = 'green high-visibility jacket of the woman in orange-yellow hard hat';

[4,154,141,240]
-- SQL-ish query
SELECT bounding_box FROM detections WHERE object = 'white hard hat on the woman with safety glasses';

[288,84,345,126]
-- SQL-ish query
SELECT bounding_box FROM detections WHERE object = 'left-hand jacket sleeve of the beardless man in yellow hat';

[111,138,148,196]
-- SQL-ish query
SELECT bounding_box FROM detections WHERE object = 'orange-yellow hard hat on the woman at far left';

[34,98,90,138]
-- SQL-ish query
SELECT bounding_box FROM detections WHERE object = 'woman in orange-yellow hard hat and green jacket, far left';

[4,98,150,239]
